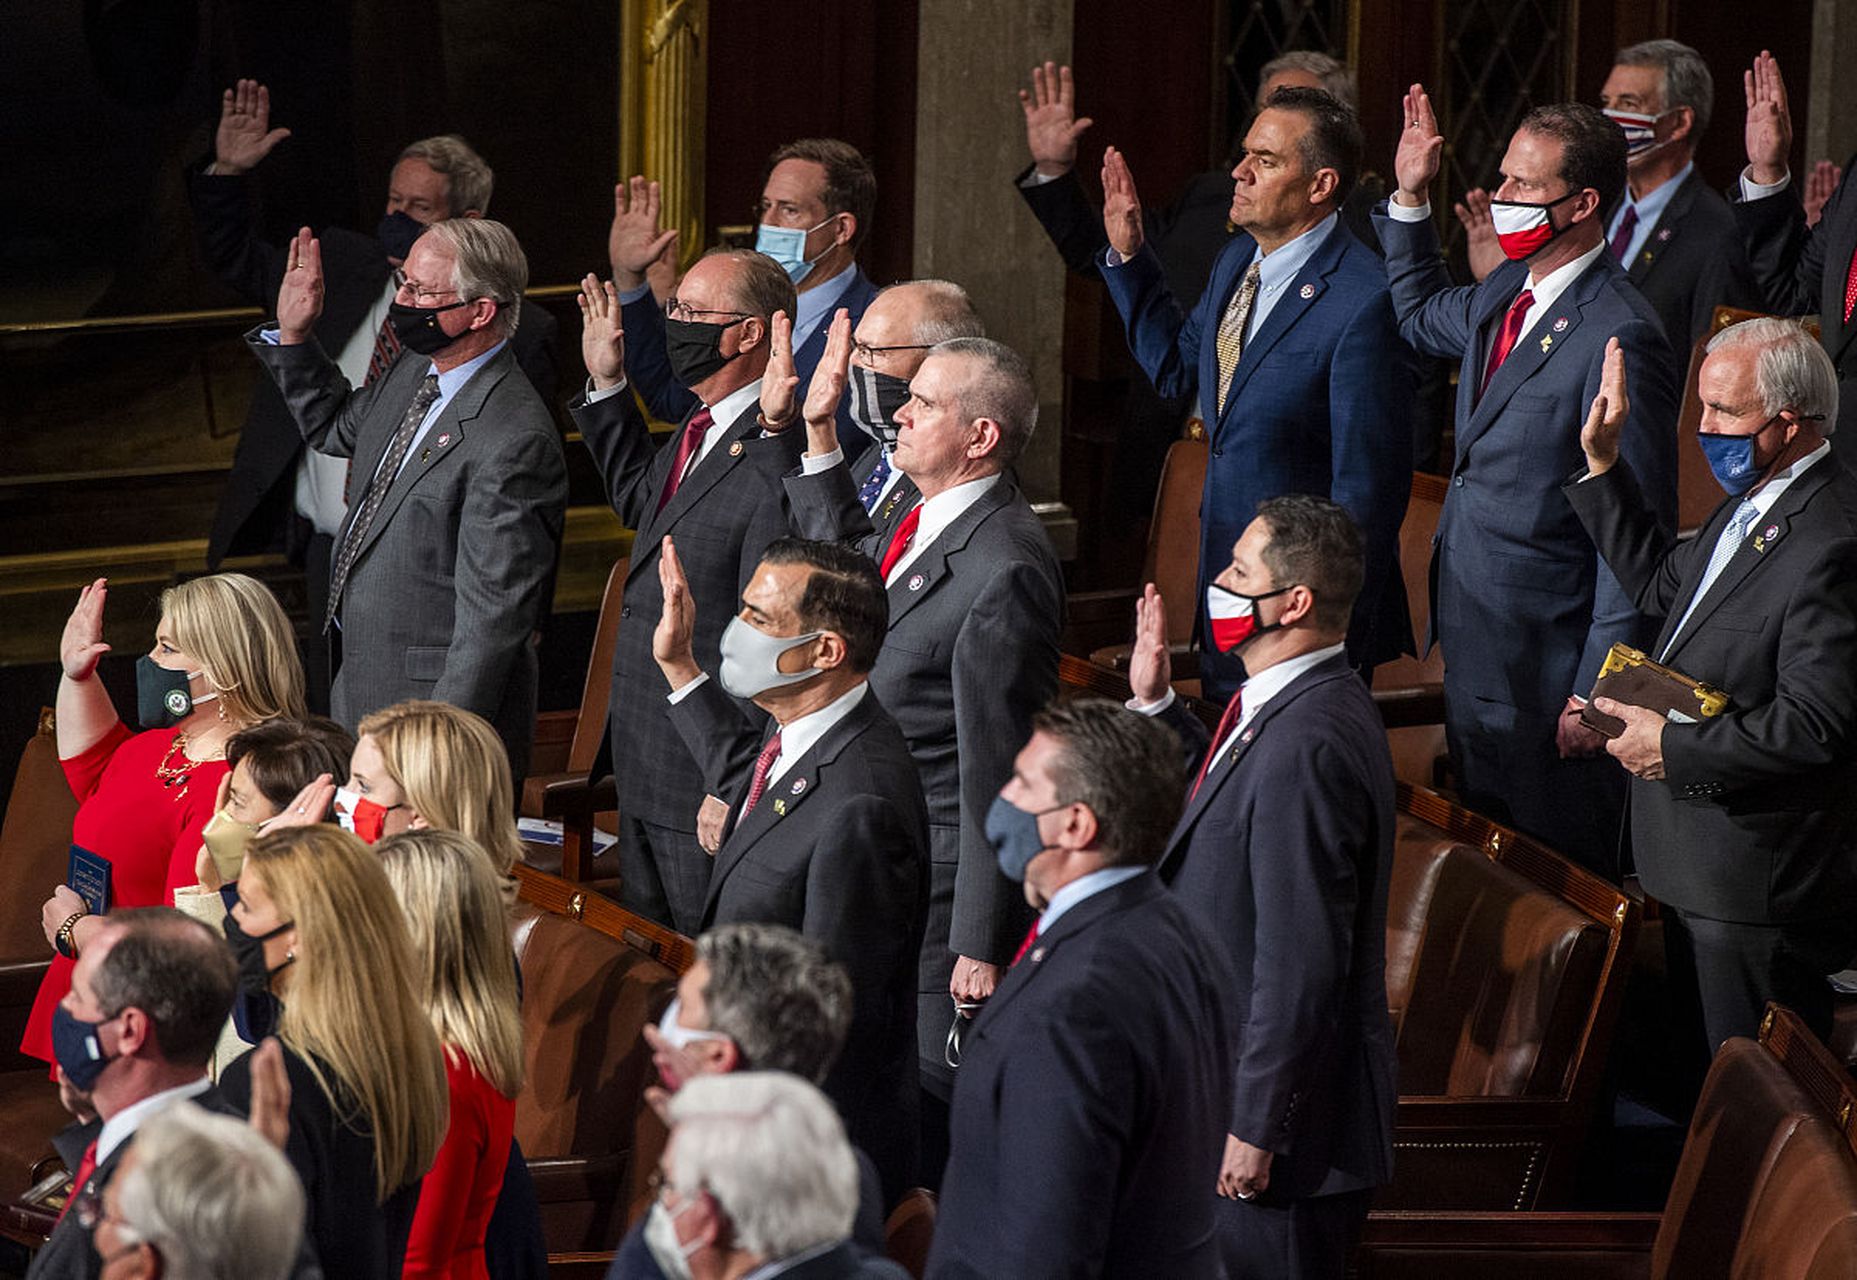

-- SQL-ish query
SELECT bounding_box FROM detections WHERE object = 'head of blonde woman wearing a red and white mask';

[336,702,522,907]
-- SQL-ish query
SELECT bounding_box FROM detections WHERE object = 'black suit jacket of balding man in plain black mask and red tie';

[568,390,804,832]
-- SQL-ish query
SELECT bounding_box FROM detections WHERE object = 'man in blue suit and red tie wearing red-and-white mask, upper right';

[1374,85,1679,877]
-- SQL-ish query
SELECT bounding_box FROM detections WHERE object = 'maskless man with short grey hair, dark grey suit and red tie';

[787,326,1064,1183]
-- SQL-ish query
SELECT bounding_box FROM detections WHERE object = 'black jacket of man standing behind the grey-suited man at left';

[188,169,557,564]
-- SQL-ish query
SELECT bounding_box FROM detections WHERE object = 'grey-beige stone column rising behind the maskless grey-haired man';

[916,0,1077,557]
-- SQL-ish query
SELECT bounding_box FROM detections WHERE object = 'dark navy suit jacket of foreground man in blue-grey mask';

[929,871,1231,1280]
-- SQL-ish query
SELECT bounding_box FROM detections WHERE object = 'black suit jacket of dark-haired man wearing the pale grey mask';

[670,680,929,1204]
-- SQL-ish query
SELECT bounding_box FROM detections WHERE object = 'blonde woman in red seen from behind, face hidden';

[377,830,539,1280]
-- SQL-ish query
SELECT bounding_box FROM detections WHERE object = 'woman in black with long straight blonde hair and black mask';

[219,825,448,1280]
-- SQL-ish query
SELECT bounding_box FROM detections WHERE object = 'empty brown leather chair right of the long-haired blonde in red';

[516,866,695,1254]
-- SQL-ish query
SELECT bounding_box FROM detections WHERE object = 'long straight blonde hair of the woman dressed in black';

[245,825,449,1204]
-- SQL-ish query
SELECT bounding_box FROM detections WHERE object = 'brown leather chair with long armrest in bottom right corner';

[1356,1005,1857,1280]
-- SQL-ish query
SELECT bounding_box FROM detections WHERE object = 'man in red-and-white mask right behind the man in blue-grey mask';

[1129,494,1396,1280]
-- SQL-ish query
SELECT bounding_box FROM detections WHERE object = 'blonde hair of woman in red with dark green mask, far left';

[162,574,306,725]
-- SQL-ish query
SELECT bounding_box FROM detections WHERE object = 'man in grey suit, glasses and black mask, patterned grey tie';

[245,217,568,780]
